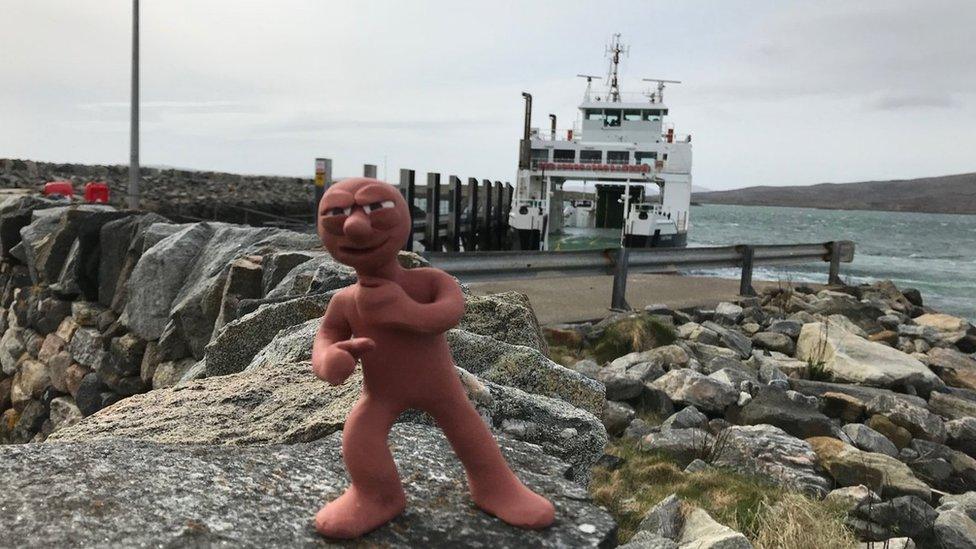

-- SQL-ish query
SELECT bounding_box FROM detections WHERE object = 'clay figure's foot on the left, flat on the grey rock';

[315,486,407,539]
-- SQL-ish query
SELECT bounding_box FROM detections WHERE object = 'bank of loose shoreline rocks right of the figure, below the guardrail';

[547,282,976,548]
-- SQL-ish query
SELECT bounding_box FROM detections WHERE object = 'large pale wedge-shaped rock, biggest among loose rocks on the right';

[796,322,944,394]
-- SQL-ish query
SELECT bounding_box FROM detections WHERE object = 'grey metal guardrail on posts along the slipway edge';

[424,240,854,310]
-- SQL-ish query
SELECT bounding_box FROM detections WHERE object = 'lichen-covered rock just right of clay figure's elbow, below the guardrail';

[458,292,549,355]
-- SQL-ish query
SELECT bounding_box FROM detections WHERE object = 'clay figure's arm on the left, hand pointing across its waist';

[312,295,376,385]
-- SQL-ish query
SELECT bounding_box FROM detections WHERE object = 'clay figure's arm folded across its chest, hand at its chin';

[356,269,464,335]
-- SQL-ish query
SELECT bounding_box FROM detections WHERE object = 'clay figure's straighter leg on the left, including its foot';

[315,395,406,539]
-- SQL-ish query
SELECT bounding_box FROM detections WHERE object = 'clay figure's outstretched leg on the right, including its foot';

[427,384,556,529]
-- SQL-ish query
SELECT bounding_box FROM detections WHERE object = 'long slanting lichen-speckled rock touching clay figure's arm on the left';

[204,293,333,377]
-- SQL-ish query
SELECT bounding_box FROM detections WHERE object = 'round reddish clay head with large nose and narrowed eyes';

[318,177,412,275]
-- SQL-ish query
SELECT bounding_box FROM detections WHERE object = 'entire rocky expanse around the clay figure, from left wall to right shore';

[0,192,976,548]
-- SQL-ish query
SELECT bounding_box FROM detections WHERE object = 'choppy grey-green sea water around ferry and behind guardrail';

[554,204,976,321]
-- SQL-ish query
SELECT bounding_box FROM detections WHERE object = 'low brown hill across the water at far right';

[692,173,976,214]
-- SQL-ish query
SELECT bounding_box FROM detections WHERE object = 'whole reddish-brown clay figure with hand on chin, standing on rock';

[312,178,555,538]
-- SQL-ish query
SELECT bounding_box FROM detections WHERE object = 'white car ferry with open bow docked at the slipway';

[509,34,691,250]
